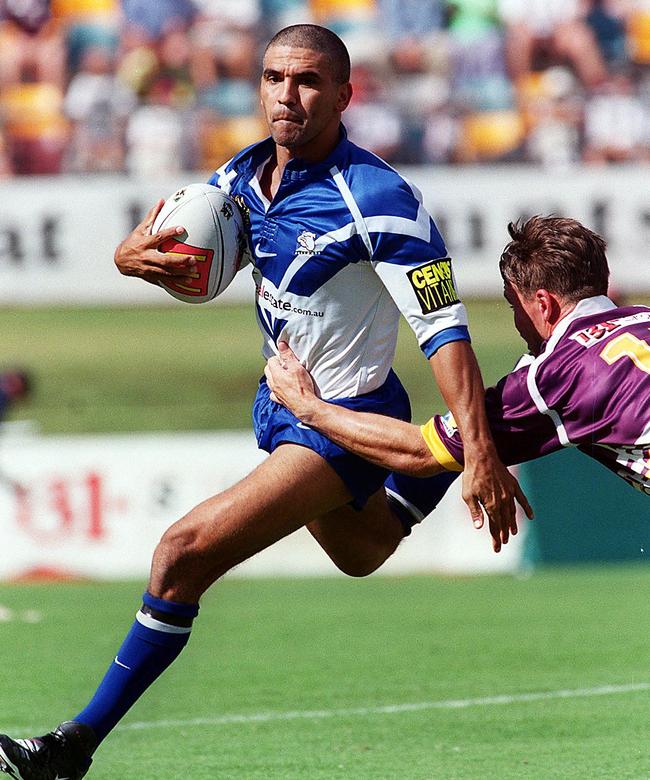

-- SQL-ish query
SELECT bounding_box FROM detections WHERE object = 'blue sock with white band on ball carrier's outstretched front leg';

[73,593,199,744]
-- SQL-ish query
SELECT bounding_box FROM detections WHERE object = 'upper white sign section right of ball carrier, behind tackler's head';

[405,166,650,296]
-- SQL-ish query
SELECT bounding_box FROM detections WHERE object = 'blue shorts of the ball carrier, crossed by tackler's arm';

[253,371,411,509]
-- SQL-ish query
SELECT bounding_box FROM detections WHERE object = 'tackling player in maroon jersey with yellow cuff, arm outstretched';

[266,217,650,536]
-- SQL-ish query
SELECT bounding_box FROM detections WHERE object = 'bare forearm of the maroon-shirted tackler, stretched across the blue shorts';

[299,397,443,477]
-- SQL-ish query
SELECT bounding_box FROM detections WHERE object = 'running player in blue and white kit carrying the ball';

[0,25,528,780]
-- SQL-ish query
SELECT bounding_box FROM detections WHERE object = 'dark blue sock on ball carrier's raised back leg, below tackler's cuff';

[384,471,458,536]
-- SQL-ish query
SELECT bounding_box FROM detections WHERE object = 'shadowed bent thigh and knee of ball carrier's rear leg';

[307,488,404,577]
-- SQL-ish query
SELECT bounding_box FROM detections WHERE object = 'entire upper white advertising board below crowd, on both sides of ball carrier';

[0,166,650,306]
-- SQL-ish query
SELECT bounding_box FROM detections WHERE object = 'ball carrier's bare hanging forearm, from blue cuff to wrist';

[429,341,496,462]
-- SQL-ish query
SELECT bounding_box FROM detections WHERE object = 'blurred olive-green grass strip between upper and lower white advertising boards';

[0,301,524,433]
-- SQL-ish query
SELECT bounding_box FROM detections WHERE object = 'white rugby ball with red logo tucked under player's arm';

[151,183,247,303]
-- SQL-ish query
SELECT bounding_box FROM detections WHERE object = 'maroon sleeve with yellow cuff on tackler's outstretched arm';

[421,366,562,471]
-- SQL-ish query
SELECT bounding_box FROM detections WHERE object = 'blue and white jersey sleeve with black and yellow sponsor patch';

[366,179,470,357]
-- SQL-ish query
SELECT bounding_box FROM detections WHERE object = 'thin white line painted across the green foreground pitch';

[0,682,650,734]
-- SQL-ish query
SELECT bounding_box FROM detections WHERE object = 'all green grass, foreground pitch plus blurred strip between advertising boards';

[0,302,650,780]
